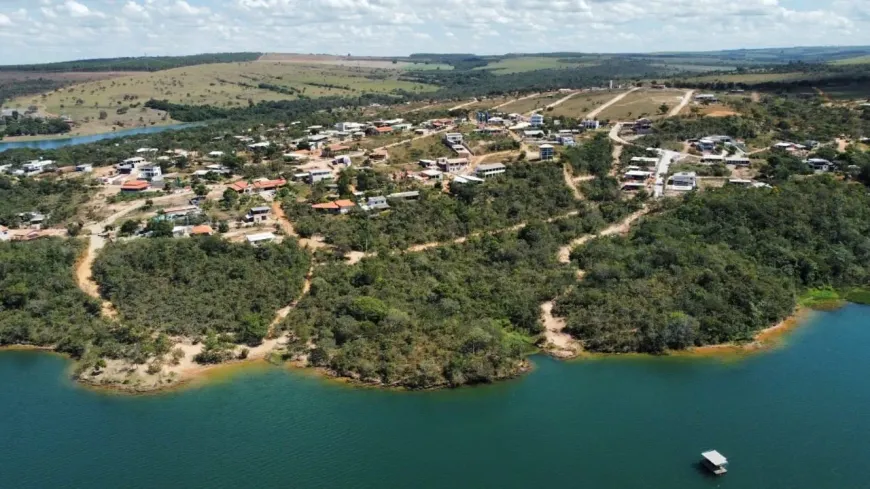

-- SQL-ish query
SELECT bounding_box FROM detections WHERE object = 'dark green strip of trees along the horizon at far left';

[0,53,261,72]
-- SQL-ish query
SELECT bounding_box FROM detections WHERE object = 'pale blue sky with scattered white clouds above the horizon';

[0,0,870,64]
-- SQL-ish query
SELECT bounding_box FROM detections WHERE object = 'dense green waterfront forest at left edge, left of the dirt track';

[0,239,109,357]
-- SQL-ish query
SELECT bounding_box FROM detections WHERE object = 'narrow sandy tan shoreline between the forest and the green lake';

[0,307,814,396]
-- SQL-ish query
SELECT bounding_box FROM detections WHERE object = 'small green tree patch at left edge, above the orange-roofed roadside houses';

[0,175,93,227]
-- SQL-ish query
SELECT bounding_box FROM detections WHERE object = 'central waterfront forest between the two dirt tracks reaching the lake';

[283,215,603,388]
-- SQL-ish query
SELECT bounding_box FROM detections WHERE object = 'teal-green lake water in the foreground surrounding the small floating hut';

[0,306,870,489]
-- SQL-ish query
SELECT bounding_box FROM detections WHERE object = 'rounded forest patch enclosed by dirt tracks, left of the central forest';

[94,237,310,343]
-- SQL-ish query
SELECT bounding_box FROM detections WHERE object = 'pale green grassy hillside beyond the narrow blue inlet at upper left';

[6,61,437,137]
